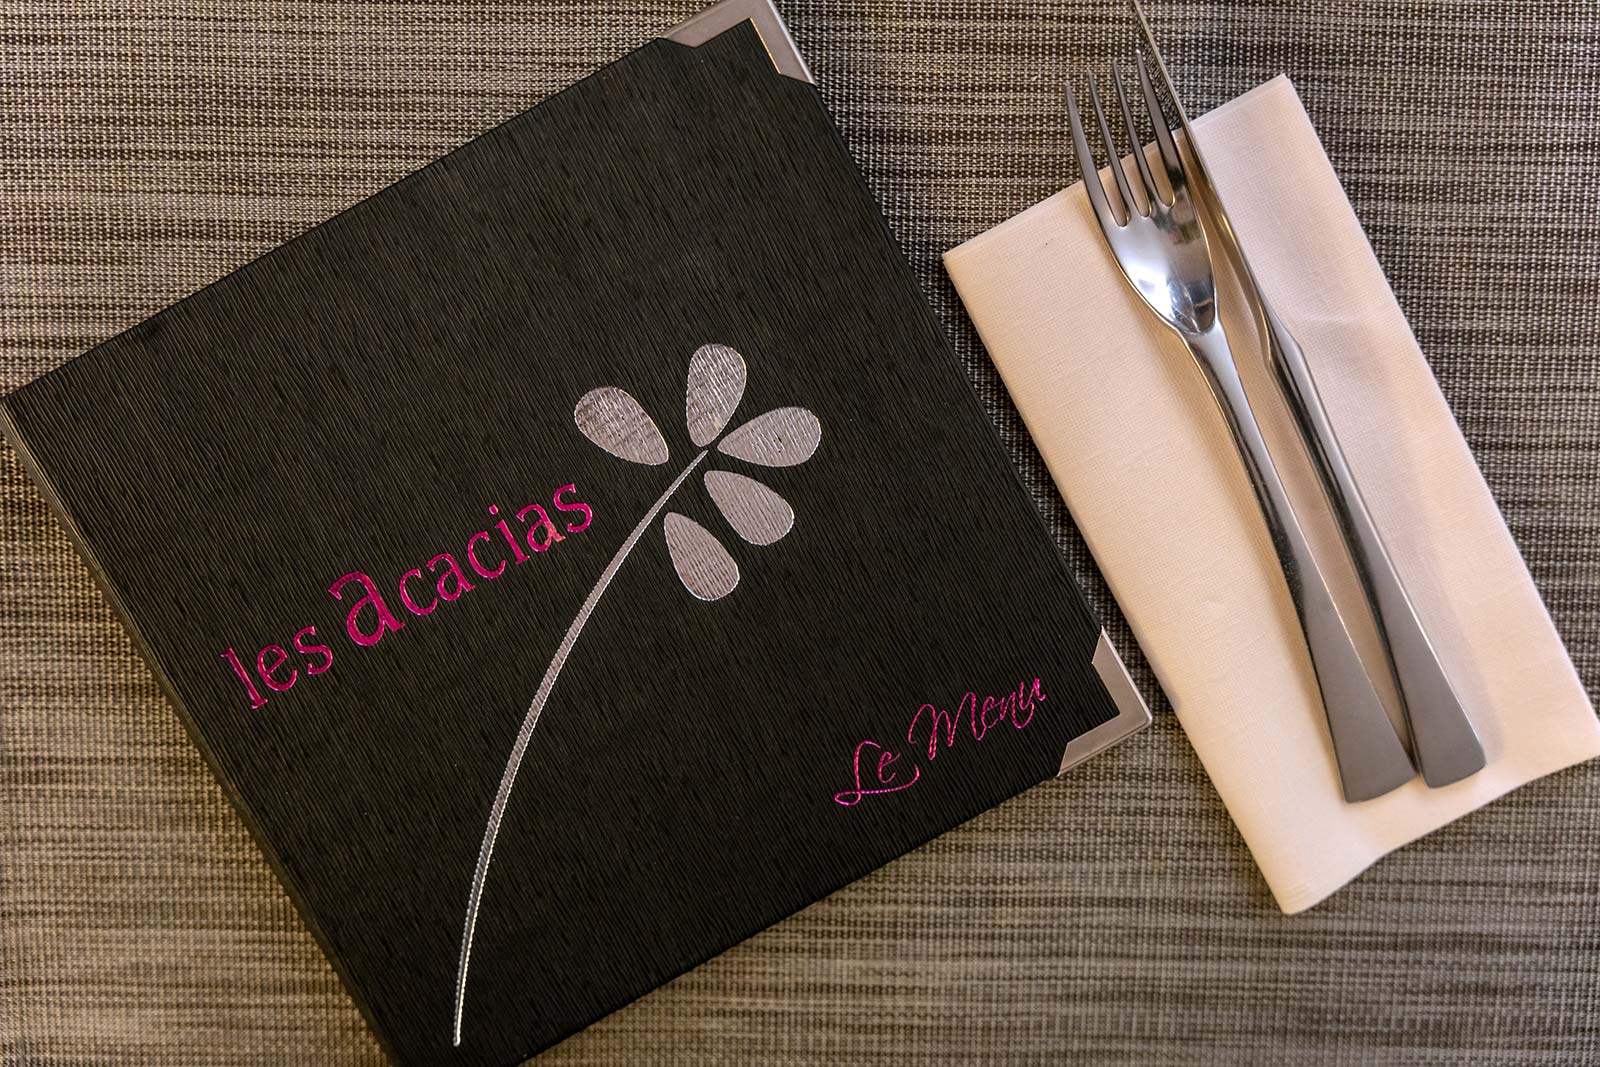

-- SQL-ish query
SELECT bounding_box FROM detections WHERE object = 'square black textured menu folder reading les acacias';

[3,0,1147,1064]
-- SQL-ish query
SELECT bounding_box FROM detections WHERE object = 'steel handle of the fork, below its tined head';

[1184,323,1414,803]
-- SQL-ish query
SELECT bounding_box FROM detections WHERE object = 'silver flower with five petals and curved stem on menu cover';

[453,344,822,1045]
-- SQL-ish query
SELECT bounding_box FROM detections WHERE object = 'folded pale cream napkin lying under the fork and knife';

[946,77,1600,912]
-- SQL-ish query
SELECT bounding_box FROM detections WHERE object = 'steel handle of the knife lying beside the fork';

[1267,309,1485,787]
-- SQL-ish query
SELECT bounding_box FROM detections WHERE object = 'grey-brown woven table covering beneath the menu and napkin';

[0,0,1600,1067]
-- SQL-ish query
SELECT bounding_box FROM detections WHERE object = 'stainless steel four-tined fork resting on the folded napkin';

[1067,58,1413,803]
